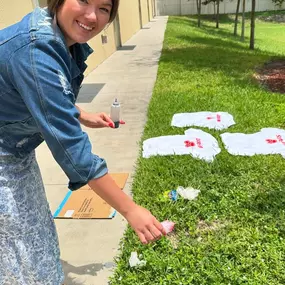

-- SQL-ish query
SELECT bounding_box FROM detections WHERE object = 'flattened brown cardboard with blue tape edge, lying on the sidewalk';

[54,173,129,219]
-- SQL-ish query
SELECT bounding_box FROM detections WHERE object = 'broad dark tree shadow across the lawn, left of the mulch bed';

[160,35,272,79]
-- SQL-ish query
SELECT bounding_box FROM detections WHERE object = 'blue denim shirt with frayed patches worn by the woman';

[0,8,108,190]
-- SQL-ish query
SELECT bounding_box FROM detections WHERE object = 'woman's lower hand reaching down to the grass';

[124,205,166,244]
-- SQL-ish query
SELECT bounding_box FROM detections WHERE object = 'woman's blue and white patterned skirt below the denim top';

[0,147,64,285]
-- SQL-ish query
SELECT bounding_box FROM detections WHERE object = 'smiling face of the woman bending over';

[56,0,112,46]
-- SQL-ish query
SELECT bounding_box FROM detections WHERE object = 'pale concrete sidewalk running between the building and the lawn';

[37,17,167,285]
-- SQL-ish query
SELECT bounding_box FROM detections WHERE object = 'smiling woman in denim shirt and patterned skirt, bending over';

[0,0,165,285]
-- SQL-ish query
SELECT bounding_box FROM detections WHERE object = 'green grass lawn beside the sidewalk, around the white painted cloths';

[111,10,285,285]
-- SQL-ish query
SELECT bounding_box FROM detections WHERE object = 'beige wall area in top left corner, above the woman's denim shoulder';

[0,0,34,30]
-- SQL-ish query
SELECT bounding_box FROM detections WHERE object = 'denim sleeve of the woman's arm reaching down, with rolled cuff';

[9,39,108,190]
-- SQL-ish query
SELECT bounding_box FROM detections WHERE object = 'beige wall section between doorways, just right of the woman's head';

[119,0,141,44]
